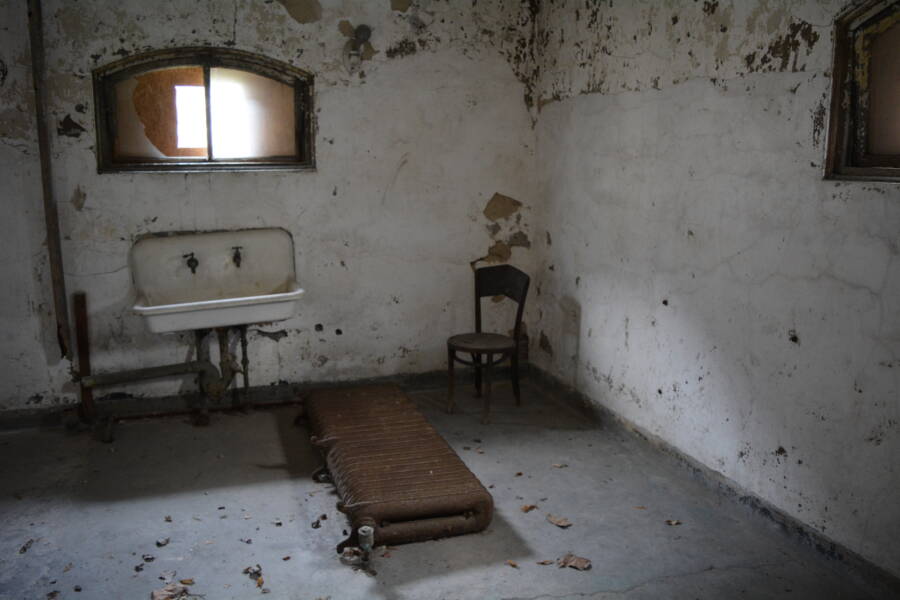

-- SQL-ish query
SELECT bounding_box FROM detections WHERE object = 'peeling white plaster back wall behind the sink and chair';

[0,0,535,410]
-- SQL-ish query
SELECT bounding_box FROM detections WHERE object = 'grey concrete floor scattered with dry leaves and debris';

[0,385,879,600]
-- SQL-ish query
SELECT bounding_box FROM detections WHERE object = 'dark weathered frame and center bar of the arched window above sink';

[93,47,315,173]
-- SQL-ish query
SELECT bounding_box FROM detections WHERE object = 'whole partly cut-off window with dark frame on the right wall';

[826,0,900,181]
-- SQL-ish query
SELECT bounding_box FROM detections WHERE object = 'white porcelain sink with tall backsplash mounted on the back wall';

[130,228,303,333]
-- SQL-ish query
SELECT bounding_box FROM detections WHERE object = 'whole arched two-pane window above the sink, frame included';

[94,48,314,173]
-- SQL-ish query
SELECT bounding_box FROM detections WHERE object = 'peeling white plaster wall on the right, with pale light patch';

[532,1,900,575]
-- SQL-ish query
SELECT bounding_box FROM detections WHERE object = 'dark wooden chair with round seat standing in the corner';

[447,265,531,423]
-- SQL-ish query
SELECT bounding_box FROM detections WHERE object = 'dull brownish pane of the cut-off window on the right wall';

[868,23,900,154]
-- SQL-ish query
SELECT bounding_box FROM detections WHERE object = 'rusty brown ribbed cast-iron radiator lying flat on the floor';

[305,385,494,552]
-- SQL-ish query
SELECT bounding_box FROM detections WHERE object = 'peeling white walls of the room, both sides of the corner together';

[0,0,900,574]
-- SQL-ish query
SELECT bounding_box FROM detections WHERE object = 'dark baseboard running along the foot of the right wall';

[530,365,900,598]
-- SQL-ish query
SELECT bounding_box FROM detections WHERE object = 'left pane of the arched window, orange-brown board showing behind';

[113,67,207,160]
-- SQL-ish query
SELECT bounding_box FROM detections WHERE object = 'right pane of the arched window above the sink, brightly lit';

[209,68,297,159]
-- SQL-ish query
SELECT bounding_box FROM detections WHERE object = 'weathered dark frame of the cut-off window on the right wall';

[825,0,900,181]
